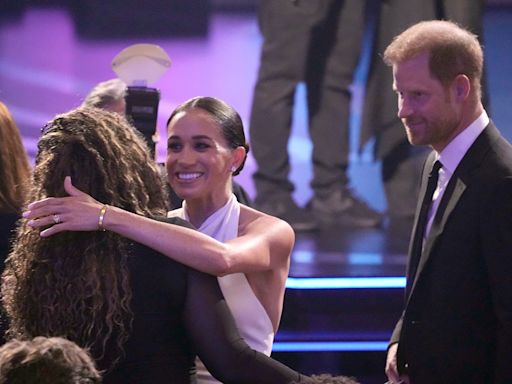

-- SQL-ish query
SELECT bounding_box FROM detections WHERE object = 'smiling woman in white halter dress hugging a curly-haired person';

[24,97,294,383]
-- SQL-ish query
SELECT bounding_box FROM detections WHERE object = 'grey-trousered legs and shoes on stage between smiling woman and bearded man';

[249,0,383,231]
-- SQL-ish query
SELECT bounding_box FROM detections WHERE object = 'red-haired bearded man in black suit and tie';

[384,21,512,384]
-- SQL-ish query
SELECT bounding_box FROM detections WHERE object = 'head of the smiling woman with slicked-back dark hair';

[167,97,249,220]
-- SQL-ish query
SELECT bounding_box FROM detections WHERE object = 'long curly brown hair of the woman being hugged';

[2,108,166,368]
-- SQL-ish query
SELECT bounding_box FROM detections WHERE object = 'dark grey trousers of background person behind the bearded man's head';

[360,0,489,217]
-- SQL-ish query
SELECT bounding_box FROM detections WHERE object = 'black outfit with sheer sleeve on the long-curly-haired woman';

[99,218,301,384]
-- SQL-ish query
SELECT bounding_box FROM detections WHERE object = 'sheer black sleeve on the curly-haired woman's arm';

[184,270,305,384]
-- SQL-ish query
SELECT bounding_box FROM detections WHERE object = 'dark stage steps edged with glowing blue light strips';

[272,277,405,384]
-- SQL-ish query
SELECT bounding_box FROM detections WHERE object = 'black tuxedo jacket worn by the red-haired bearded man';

[391,123,512,384]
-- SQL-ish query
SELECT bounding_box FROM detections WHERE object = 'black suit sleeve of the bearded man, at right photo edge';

[482,177,512,383]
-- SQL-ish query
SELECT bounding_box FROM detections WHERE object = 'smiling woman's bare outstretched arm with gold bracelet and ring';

[24,177,294,276]
